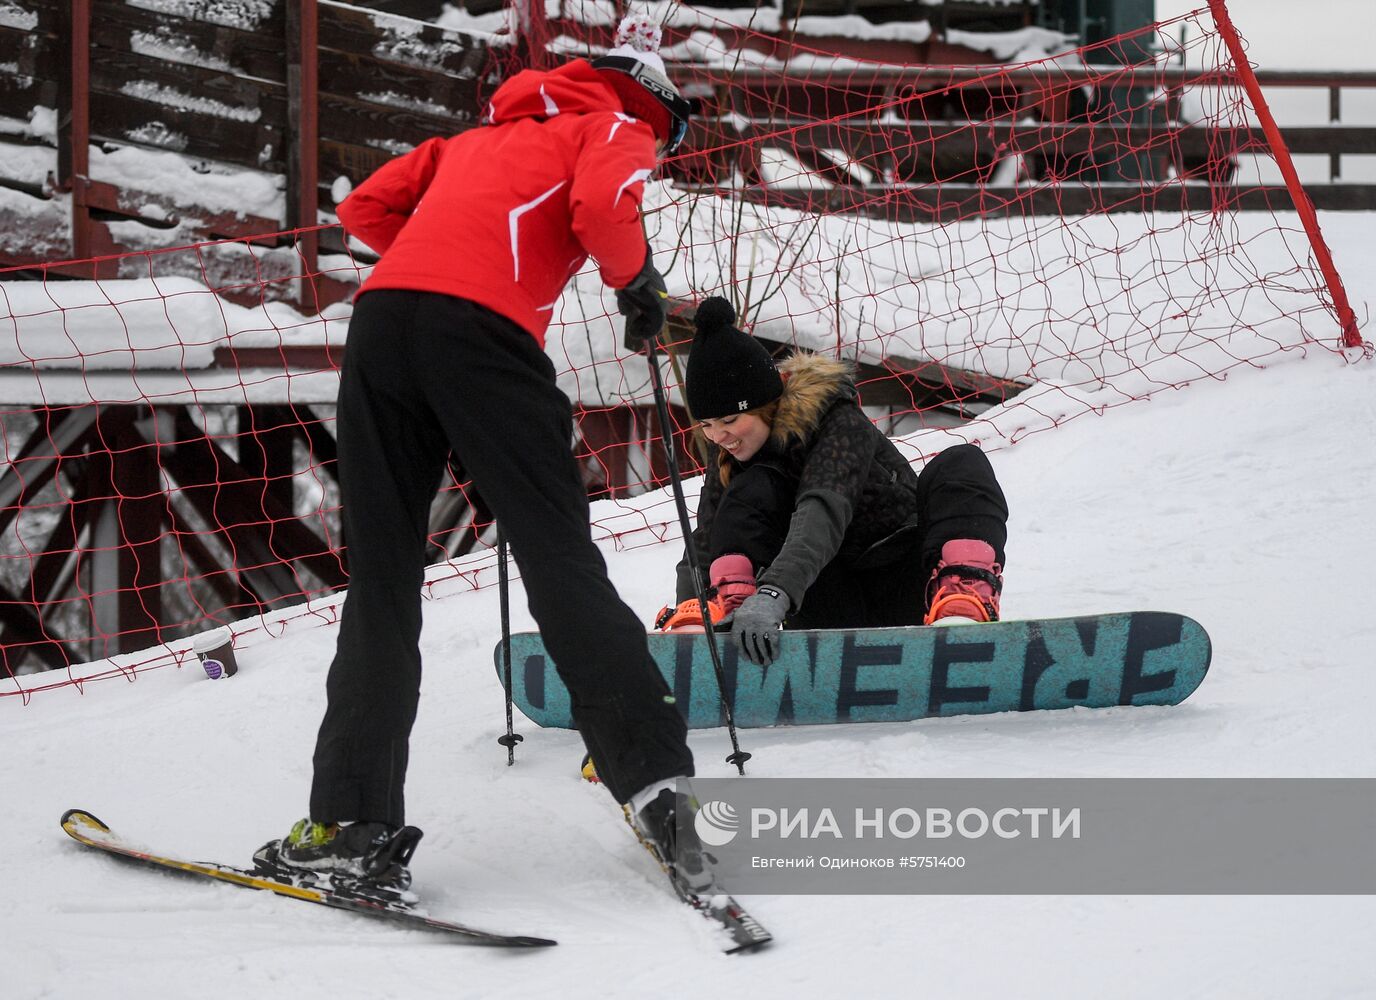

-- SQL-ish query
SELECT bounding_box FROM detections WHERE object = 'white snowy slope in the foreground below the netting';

[0,217,1376,1000]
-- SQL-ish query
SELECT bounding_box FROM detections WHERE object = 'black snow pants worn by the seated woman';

[707,444,1009,629]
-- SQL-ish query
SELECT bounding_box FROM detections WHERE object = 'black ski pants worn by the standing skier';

[311,290,694,825]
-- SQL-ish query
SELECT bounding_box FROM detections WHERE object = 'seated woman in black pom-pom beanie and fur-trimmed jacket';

[660,297,1009,664]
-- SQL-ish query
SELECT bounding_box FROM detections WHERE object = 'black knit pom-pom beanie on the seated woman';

[684,296,783,420]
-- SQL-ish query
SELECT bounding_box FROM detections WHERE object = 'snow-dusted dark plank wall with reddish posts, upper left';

[0,0,506,286]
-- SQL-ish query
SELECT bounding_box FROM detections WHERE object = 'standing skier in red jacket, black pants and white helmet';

[269,17,707,902]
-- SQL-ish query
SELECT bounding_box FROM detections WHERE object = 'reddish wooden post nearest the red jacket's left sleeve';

[286,0,321,314]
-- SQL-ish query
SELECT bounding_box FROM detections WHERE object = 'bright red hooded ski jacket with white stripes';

[338,59,655,345]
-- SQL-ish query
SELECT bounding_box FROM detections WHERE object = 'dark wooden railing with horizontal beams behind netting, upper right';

[674,65,1376,221]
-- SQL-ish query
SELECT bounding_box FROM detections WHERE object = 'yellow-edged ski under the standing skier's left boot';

[62,809,559,948]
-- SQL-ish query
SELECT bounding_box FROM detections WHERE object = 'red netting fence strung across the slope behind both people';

[0,4,1359,695]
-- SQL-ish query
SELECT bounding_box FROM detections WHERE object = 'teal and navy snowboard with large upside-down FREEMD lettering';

[493,611,1212,729]
